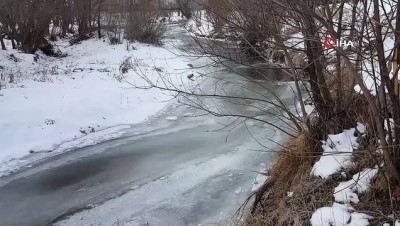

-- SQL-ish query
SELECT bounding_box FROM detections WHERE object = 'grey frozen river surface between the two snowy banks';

[0,24,294,226]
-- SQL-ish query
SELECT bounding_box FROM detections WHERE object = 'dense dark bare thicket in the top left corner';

[0,0,105,53]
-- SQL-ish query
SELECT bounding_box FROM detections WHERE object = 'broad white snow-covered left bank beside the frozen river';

[0,28,205,176]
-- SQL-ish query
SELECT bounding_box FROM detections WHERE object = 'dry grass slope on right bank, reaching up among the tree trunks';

[238,75,400,226]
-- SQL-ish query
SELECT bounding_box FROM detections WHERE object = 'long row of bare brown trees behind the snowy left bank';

[0,0,195,53]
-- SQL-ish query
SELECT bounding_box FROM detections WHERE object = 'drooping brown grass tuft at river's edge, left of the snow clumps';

[245,133,324,226]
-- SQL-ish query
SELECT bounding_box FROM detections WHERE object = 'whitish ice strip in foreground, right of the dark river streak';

[56,145,262,225]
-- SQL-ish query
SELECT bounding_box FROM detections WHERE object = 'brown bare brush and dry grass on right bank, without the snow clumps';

[184,0,400,222]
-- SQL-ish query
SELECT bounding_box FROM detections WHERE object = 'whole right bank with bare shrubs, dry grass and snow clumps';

[196,0,400,226]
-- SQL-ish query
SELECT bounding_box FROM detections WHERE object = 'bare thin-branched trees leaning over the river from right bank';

[134,0,400,185]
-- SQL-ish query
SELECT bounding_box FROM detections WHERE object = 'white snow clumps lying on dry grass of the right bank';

[310,123,386,226]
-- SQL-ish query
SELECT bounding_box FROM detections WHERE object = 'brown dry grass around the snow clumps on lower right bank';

[244,125,400,226]
